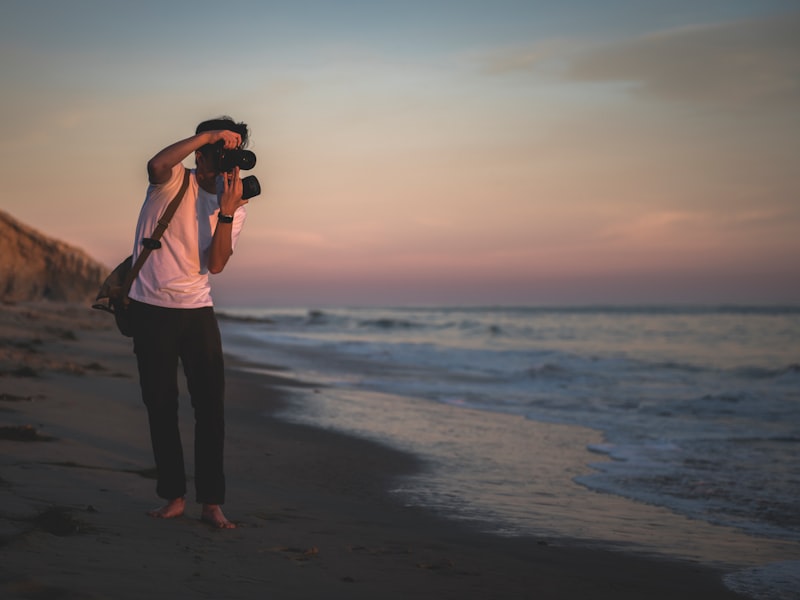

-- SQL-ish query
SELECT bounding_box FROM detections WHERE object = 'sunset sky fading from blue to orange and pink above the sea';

[0,0,800,307]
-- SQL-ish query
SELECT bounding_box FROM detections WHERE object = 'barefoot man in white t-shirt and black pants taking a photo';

[130,117,248,528]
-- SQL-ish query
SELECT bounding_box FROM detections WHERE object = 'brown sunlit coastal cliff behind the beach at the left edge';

[0,211,109,302]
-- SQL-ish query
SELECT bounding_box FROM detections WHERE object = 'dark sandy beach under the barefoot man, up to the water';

[0,303,752,600]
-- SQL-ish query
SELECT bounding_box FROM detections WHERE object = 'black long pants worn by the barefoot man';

[131,302,225,504]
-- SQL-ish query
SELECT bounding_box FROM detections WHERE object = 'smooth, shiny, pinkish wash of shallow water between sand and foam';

[225,350,800,568]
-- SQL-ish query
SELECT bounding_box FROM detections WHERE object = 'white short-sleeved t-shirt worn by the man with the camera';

[130,164,247,308]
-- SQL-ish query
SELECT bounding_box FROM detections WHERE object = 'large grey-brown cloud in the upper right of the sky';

[567,12,800,110]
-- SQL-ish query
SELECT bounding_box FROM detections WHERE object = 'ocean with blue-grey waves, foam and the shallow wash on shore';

[218,306,800,598]
